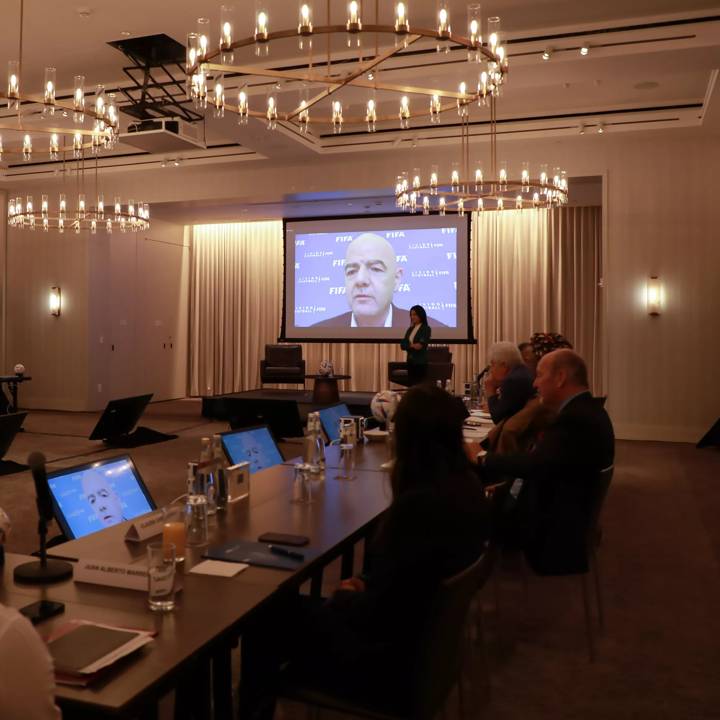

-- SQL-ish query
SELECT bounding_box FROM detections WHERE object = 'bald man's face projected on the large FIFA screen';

[345,233,402,327]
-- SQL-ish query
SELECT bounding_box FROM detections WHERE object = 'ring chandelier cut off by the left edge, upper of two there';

[0,0,120,162]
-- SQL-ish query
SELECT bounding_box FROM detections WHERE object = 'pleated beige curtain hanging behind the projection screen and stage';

[190,208,603,395]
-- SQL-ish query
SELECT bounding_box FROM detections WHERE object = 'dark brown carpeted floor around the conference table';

[0,400,720,720]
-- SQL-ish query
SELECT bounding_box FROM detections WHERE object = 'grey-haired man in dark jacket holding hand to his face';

[485,342,535,424]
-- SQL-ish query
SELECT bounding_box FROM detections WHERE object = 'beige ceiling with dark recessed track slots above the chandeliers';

[0,0,720,214]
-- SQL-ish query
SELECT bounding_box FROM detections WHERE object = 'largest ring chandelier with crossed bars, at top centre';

[186,0,508,134]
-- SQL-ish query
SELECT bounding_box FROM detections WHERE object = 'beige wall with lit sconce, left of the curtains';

[4,215,188,410]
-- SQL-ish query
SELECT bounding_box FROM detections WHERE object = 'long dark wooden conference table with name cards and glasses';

[0,450,392,718]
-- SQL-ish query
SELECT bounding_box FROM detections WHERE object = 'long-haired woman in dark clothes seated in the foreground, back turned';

[240,386,490,720]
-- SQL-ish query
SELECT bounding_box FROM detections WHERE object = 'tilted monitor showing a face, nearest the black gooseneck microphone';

[48,455,157,540]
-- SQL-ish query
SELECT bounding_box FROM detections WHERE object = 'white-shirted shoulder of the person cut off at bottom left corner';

[0,605,61,720]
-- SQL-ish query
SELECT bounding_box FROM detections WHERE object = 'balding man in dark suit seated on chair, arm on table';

[481,350,615,574]
